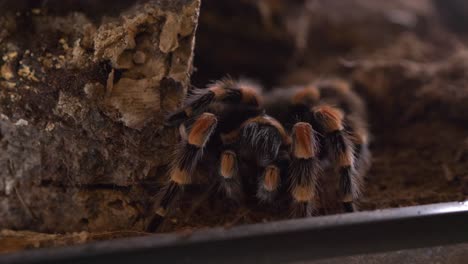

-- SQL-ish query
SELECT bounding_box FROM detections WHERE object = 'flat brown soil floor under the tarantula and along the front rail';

[0,117,468,253]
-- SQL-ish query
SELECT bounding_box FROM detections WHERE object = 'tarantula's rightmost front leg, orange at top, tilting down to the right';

[313,106,359,212]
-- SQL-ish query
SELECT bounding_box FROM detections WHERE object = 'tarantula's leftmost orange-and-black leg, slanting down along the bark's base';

[148,113,217,231]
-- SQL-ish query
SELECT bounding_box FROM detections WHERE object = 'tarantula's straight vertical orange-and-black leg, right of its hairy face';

[288,122,321,217]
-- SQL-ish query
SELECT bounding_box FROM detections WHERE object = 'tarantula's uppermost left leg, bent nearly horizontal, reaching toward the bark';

[166,79,260,125]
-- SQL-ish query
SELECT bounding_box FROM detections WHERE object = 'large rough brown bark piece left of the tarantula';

[0,0,200,232]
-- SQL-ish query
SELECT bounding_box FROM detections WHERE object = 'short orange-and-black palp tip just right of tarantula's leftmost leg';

[218,149,242,203]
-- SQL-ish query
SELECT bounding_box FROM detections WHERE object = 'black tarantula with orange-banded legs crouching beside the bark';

[149,79,370,230]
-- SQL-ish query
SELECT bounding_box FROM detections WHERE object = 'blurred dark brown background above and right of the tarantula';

[192,0,468,213]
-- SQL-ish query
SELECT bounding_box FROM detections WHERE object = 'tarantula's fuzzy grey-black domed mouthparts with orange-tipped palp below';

[241,115,290,202]
